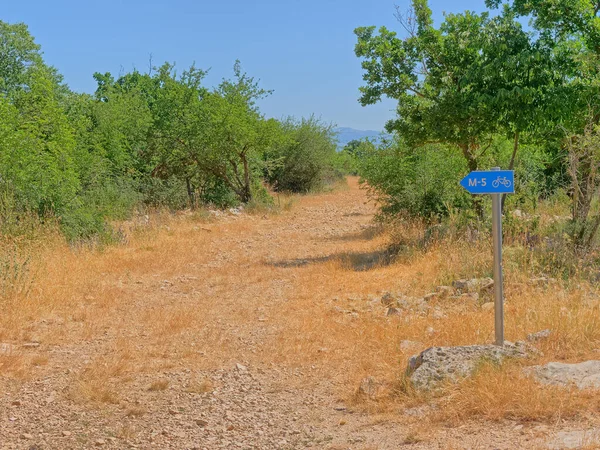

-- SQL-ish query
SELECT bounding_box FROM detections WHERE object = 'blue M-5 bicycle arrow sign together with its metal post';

[460,167,515,345]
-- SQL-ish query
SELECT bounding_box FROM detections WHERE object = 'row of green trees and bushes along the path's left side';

[0,22,342,242]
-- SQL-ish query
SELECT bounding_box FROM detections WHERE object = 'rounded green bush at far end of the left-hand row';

[265,117,340,193]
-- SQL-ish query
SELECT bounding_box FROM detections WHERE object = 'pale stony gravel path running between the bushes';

[0,180,593,450]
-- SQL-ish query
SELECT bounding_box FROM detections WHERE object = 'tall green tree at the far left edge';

[0,21,79,222]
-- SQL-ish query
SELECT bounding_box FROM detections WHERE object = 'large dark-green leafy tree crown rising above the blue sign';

[355,0,573,214]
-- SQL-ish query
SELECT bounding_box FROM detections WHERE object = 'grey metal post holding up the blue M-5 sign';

[492,167,504,346]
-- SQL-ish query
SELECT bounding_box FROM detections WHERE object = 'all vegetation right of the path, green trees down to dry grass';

[344,0,600,423]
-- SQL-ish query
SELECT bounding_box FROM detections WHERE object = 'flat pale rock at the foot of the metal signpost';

[406,342,529,389]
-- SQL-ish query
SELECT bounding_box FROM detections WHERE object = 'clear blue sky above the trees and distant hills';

[0,0,484,130]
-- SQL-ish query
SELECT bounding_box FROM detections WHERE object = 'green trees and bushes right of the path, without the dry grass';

[344,0,600,268]
